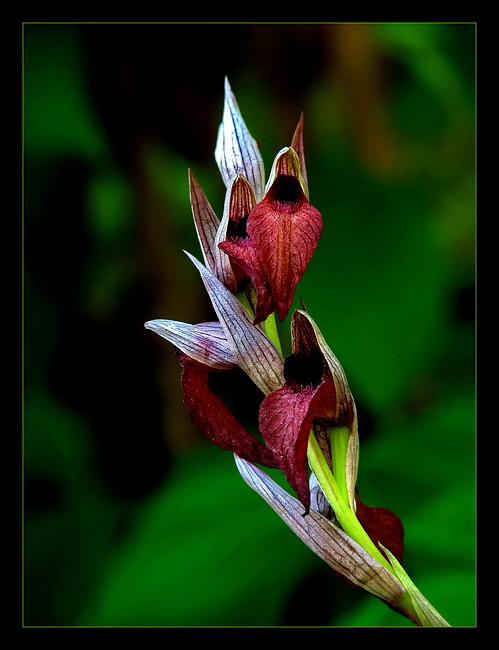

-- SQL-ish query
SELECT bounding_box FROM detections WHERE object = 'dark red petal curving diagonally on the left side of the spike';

[178,352,278,468]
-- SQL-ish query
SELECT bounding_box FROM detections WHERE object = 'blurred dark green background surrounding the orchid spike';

[23,23,476,627]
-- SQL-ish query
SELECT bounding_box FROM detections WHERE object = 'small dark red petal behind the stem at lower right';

[356,495,404,563]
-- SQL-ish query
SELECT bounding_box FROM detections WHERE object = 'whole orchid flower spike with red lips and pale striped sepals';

[145,79,449,627]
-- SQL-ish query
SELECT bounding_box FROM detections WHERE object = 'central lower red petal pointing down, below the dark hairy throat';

[259,384,332,511]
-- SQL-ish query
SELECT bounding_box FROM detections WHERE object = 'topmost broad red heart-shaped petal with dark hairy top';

[247,185,322,321]
